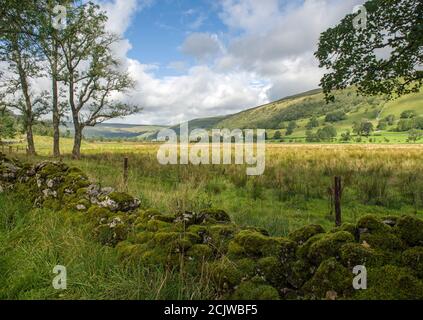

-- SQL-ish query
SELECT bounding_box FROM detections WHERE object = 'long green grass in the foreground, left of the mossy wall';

[0,194,213,300]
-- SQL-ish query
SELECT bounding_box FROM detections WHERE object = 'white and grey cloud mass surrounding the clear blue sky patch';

[92,0,364,124]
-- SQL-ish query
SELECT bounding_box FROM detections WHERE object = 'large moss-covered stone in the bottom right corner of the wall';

[353,265,423,300]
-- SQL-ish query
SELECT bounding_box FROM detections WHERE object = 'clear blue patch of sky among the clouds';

[125,0,227,77]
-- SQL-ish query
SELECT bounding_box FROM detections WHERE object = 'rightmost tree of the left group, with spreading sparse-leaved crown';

[59,3,140,159]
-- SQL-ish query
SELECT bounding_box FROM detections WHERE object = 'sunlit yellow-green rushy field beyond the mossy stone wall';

[10,137,423,235]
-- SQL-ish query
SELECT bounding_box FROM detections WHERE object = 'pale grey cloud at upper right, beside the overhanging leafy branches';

[217,0,364,100]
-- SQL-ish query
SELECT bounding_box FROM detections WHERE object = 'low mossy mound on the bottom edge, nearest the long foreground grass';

[231,278,279,300]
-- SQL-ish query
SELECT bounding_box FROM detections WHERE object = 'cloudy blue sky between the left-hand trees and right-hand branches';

[93,0,364,125]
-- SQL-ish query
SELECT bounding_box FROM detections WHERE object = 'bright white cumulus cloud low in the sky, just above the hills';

[123,60,268,124]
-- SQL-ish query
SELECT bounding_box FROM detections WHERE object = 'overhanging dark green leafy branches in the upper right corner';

[315,0,423,101]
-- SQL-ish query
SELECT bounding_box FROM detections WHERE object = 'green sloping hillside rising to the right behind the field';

[177,88,423,137]
